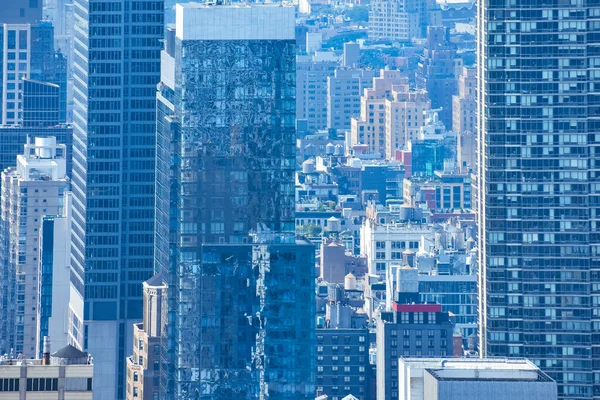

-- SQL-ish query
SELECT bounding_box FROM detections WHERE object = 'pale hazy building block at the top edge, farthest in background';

[368,0,442,43]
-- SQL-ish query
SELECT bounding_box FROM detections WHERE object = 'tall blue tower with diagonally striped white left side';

[71,0,164,400]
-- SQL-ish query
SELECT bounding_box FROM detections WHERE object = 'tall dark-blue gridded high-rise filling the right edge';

[477,0,600,399]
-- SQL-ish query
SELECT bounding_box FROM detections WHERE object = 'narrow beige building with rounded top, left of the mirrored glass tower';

[126,274,167,400]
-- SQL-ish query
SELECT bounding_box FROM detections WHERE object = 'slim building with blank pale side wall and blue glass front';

[37,192,72,356]
